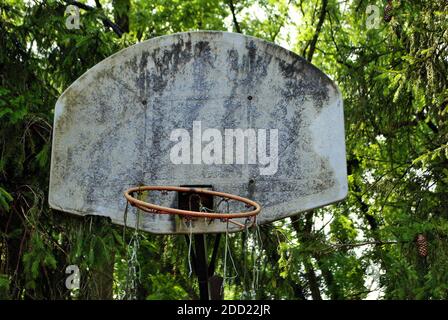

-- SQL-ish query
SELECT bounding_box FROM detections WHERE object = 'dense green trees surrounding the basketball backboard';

[0,0,448,299]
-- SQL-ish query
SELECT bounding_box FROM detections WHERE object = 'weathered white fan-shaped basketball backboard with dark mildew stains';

[49,32,347,233]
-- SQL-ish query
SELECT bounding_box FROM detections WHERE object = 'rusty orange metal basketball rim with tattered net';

[124,186,261,229]
